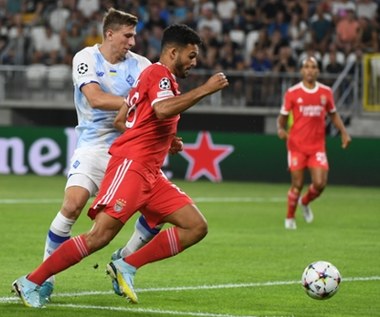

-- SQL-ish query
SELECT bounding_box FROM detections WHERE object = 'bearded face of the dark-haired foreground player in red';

[174,44,199,78]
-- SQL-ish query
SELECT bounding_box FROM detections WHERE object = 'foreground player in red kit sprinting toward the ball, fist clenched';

[13,24,228,307]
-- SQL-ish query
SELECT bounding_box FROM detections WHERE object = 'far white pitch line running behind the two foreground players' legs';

[0,197,285,205]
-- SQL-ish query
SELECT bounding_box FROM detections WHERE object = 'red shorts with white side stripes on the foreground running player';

[88,157,193,228]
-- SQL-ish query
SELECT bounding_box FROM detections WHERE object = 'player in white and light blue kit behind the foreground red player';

[40,9,166,299]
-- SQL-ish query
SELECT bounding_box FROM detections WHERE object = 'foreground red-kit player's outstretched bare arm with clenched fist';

[153,73,228,119]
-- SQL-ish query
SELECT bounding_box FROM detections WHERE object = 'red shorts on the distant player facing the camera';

[288,151,329,171]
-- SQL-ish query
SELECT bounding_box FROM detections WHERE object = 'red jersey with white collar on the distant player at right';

[281,82,336,153]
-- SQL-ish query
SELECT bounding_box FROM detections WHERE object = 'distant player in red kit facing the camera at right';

[277,57,351,229]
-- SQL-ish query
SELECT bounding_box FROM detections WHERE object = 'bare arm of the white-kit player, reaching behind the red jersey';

[81,83,125,111]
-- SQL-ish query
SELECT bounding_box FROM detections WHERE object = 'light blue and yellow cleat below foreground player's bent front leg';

[106,259,138,304]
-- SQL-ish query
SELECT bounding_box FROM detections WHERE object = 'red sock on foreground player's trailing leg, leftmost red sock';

[28,236,89,285]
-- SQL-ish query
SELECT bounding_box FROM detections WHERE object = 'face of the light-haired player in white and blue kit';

[108,25,136,60]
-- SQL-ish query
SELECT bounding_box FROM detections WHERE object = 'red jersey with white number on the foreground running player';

[110,63,180,174]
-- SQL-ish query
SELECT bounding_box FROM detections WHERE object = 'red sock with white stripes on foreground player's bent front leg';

[124,227,183,268]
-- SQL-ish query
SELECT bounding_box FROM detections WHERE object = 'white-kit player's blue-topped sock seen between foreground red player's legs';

[120,215,163,258]
